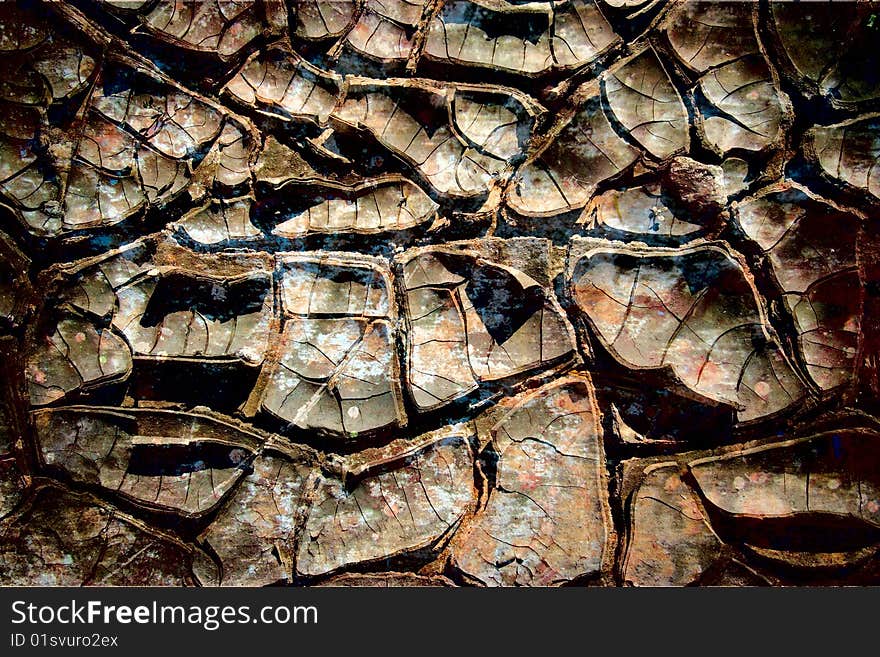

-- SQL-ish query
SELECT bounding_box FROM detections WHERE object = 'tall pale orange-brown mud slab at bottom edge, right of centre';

[452,376,614,586]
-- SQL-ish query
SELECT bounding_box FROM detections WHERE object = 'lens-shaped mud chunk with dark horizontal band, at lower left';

[33,407,260,516]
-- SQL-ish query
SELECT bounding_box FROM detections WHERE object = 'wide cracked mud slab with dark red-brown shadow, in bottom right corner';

[622,429,880,586]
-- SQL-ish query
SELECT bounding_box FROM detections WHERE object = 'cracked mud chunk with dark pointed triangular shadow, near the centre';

[397,247,574,410]
